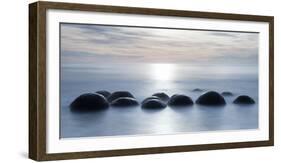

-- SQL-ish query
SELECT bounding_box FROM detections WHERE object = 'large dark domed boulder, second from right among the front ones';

[196,91,226,106]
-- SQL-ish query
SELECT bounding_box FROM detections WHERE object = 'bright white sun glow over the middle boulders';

[151,63,175,81]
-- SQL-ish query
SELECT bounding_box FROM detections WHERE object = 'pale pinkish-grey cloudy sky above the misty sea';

[60,23,259,67]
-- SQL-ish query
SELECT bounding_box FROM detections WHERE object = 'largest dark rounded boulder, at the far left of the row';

[70,93,109,111]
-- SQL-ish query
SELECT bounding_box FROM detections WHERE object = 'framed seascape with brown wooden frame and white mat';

[29,2,274,160]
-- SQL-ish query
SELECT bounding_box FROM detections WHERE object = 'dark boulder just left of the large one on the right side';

[168,94,193,106]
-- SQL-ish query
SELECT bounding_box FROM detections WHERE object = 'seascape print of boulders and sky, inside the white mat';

[60,22,259,138]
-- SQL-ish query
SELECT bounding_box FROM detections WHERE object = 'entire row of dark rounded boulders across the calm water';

[70,89,255,111]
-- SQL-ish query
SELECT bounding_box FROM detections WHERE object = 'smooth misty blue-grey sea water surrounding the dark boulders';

[60,64,259,138]
